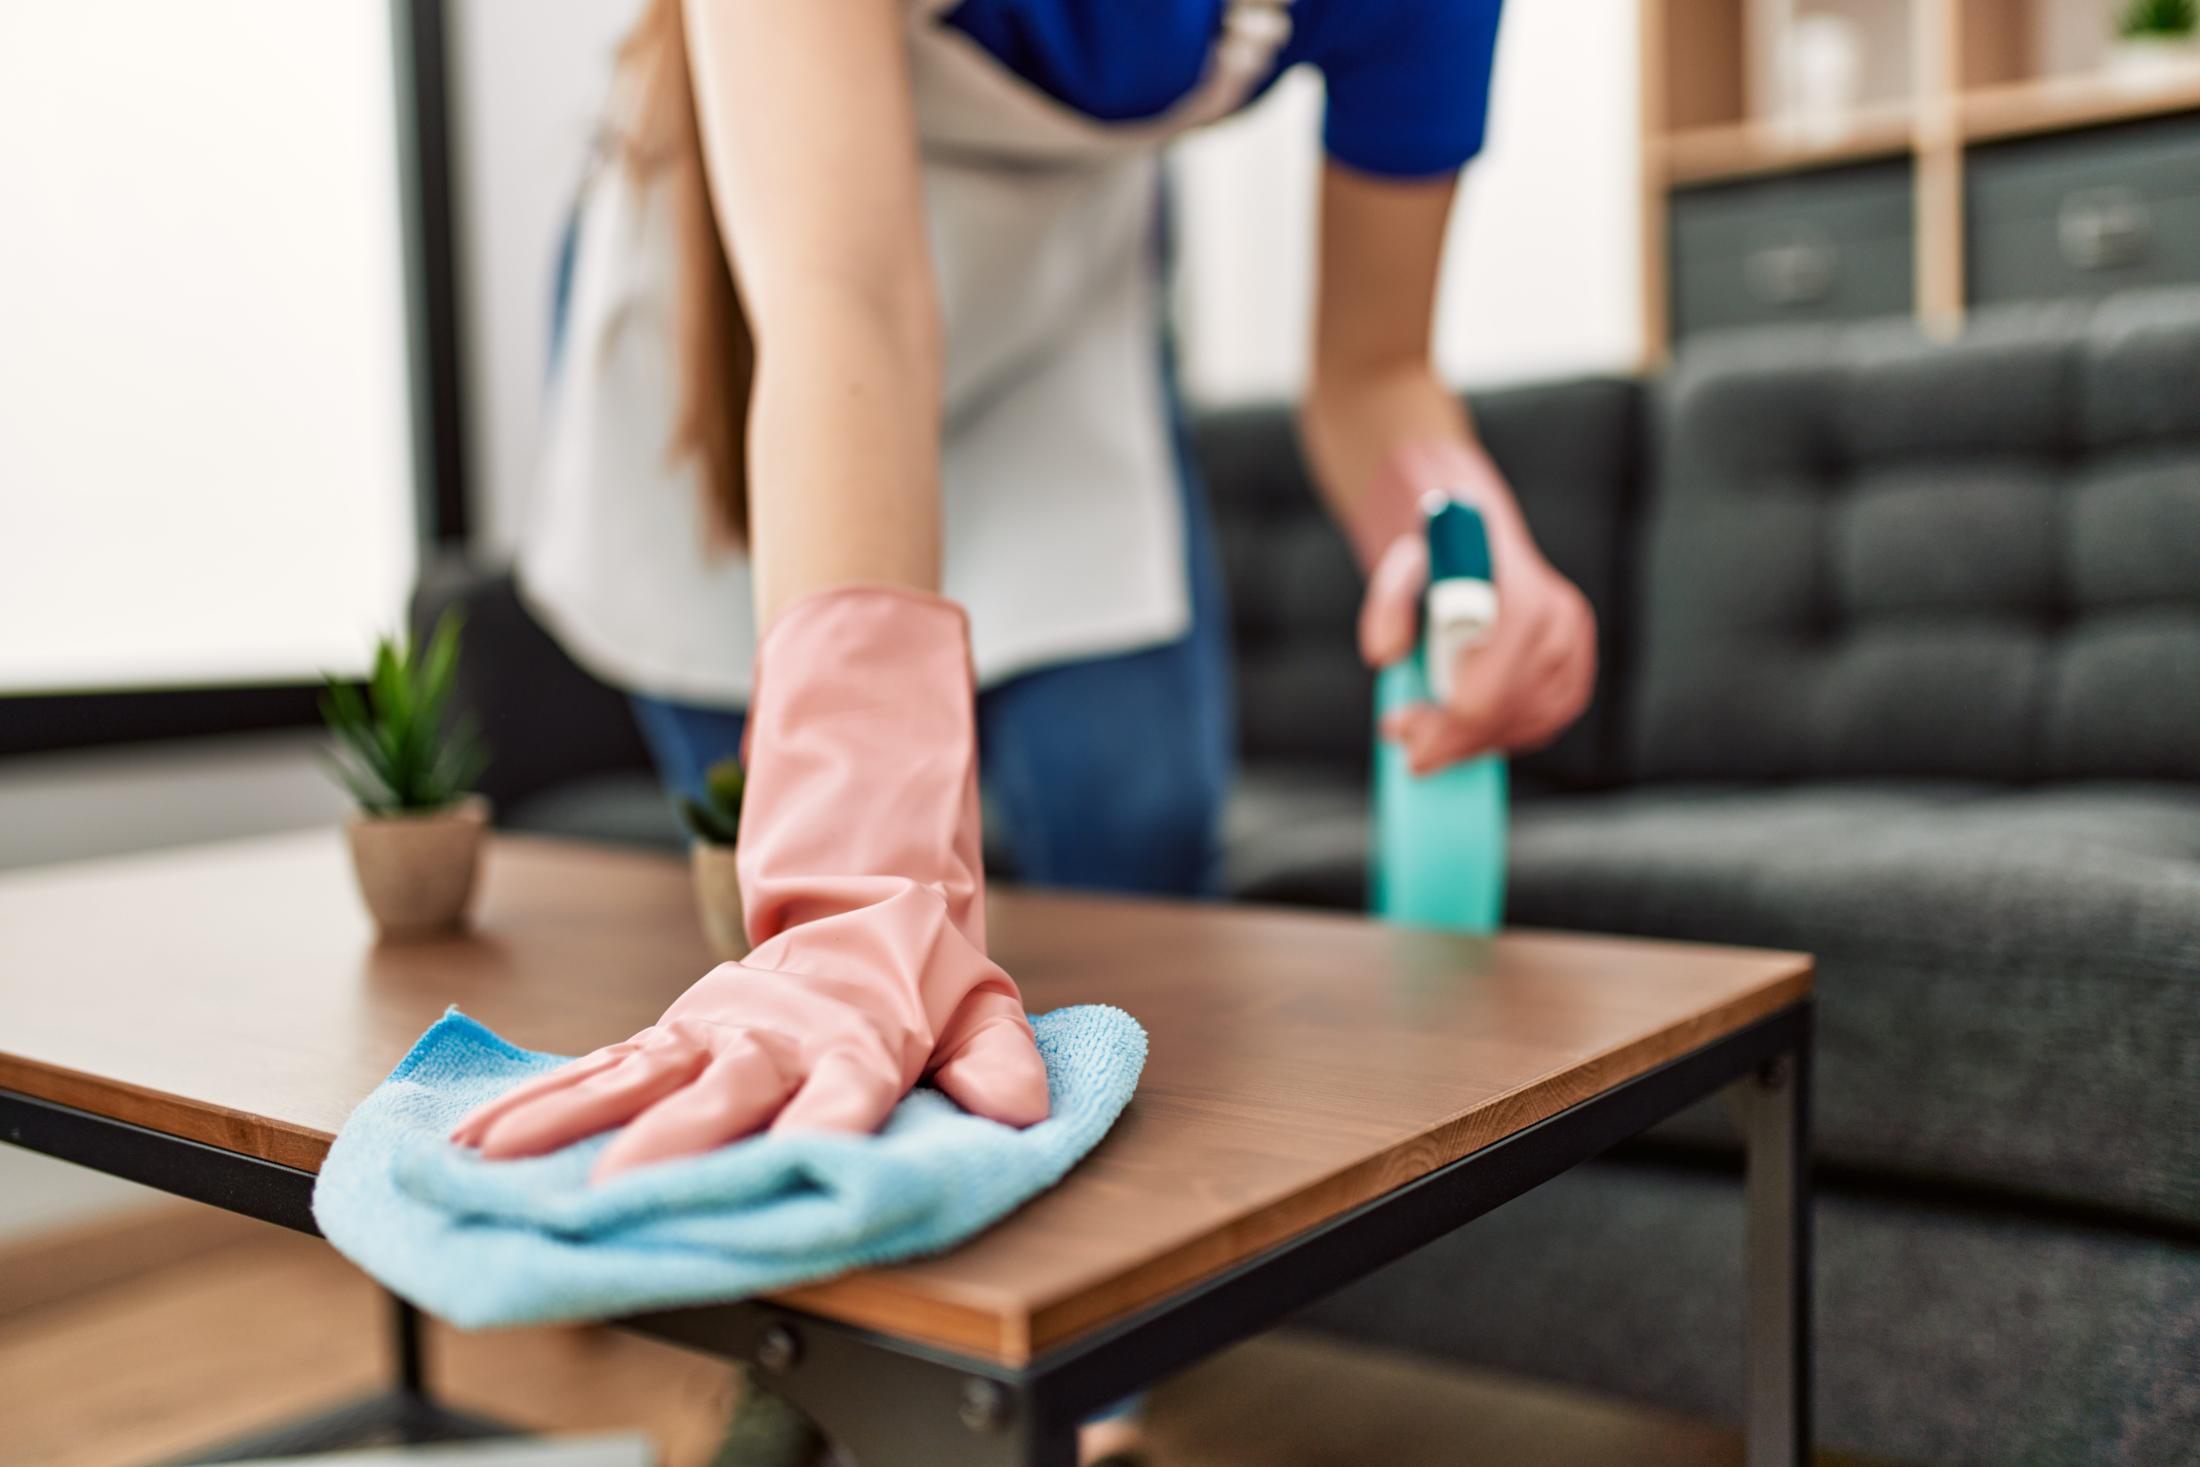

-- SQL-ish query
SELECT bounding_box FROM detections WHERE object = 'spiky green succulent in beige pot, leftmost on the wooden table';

[321,611,488,937]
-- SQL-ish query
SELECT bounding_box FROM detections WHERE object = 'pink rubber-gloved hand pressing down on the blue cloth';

[451,587,1047,1181]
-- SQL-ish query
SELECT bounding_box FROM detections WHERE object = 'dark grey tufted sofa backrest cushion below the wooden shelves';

[1630,290,2200,781]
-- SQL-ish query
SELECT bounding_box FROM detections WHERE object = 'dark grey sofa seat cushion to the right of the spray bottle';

[1507,781,2200,1227]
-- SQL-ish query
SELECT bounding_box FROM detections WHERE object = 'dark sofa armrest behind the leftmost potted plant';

[411,554,649,812]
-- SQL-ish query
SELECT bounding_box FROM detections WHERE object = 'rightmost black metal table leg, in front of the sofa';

[1729,1027,1811,1467]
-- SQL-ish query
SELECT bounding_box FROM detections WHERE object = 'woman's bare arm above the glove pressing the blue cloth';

[686,0,942,627]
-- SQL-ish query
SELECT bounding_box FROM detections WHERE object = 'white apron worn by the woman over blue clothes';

[519,0,1289,706]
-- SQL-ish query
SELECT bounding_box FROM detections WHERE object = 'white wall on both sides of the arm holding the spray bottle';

[1177,0,1643,400]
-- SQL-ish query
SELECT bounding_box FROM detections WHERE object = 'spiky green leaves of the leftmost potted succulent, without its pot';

[321,611,488,816]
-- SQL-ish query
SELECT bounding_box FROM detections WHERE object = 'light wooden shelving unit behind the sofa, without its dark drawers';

[1641,0,2200,363]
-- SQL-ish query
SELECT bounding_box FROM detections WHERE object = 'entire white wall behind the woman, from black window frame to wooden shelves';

[455,0,1643,538]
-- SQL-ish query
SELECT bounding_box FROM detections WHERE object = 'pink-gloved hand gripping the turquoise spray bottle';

[1355,440,1597,774]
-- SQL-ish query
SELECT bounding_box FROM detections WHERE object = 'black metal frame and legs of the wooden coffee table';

[0,1001,1811,1467]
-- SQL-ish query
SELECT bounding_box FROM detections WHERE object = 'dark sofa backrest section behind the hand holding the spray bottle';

[1192,378,1643,787]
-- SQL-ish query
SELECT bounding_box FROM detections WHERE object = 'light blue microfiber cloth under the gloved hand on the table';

[312,1005,1146,1328]
